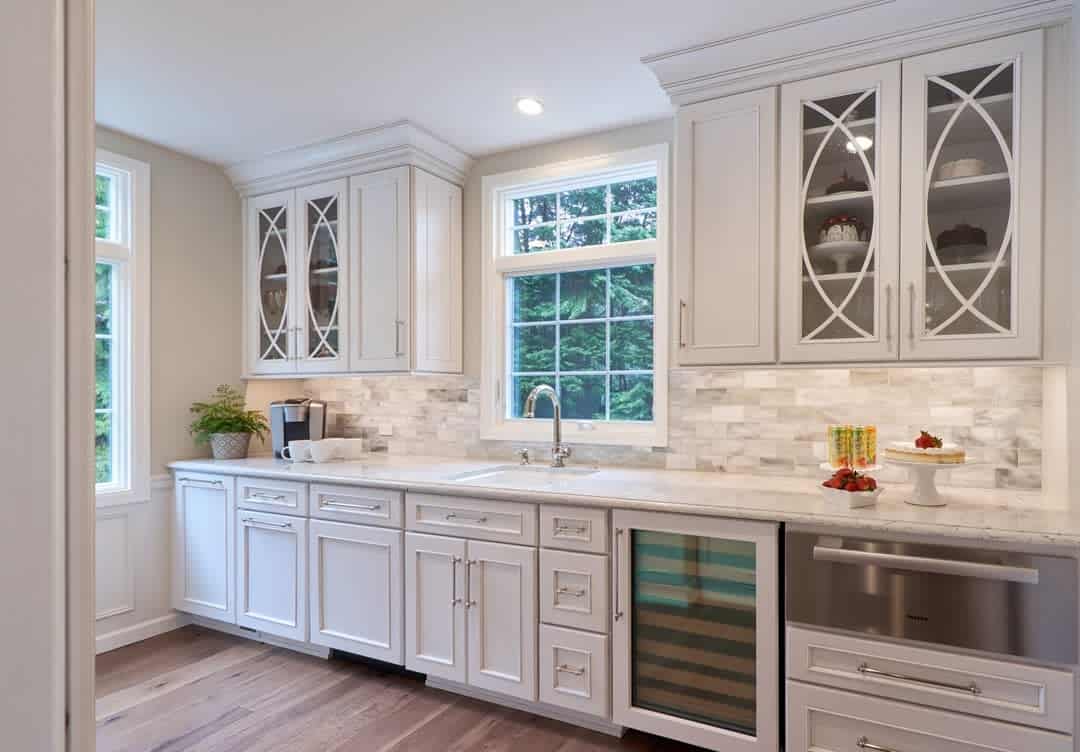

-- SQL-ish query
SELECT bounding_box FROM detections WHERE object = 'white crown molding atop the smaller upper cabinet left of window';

[225,120,473,197]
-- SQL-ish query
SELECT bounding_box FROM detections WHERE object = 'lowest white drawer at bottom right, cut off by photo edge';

[786,682,1072,752]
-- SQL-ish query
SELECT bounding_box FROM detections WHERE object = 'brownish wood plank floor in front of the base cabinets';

[97,627,697,752]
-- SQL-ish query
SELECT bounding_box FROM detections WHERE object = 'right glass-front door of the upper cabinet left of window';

[296,180,349,372]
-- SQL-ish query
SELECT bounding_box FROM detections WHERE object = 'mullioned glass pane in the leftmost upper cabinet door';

[257,206,288,361]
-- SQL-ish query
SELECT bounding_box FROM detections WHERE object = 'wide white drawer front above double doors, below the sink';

[405,494,537,546]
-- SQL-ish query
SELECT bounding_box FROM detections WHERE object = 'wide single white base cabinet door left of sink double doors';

[308,520,405,664]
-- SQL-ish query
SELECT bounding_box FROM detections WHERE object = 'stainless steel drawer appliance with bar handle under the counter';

[784,531,1078,663]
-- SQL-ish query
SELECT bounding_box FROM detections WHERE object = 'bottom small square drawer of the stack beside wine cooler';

[540,625,610,719]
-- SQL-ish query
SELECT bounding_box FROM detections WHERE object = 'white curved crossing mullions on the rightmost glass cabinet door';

[923,62,1016,337]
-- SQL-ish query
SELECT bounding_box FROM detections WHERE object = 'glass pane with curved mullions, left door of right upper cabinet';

[799,89,878,343]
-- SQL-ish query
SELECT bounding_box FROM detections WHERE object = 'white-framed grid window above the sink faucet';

[482,145,669,445]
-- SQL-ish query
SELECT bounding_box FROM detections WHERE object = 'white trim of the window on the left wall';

[95,149,150,508]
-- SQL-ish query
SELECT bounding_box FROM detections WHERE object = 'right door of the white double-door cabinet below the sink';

[465,540,537,701]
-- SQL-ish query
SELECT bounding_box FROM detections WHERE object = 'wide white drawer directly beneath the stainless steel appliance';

[787,627,1075,734]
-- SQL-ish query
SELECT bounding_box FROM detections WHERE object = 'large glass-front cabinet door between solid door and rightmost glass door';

[780,63,900,362]
